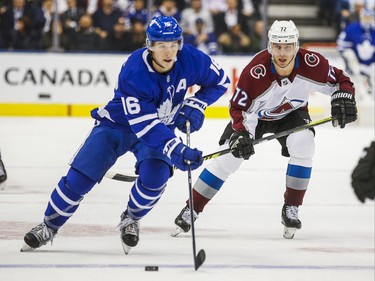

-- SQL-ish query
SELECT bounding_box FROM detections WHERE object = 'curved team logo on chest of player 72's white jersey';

[258,97,303,120]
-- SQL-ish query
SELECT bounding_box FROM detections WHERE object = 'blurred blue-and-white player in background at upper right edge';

[337,8,375,100]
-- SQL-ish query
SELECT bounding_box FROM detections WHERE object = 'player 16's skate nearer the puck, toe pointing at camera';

[117,211,139,255]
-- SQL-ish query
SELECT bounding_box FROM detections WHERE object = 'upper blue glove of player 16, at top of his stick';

[174,98,207,134]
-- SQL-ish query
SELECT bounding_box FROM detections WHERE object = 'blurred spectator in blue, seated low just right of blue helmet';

[184,18,218,55]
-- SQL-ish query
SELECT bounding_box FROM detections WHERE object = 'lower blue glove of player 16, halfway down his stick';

[163,138,203,171]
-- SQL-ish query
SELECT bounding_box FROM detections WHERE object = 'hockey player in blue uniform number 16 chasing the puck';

[21,16,229,254]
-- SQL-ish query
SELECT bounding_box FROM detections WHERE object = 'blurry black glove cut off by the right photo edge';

[352,141,375,203]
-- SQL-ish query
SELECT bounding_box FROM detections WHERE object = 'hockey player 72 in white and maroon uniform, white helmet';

[172,21,357,239]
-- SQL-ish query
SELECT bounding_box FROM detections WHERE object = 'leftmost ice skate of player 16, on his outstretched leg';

[21,222,57,252]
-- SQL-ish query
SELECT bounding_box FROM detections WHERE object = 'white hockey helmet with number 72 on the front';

[268,20,299,53]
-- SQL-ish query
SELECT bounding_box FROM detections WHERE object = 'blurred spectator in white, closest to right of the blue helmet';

[181,0,214,34]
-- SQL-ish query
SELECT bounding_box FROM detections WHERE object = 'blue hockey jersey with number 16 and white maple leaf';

[91,45,229,152]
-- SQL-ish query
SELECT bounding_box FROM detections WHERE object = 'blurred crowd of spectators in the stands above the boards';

[0,0,374,55]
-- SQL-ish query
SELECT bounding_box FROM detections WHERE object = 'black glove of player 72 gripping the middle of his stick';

[229,130,255,160]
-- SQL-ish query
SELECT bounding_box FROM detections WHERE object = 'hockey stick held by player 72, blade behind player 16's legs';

[105,117,333,182]
